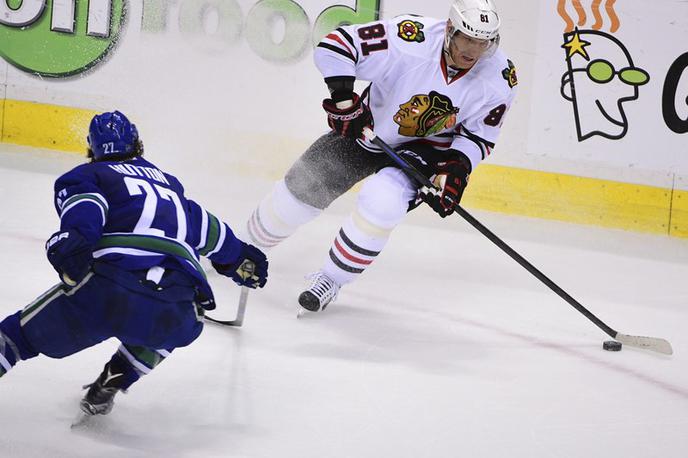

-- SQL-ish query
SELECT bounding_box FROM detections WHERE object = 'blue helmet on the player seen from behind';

[86,111,139,161]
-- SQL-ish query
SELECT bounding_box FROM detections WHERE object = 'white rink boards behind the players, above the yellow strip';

[0,0,688,184]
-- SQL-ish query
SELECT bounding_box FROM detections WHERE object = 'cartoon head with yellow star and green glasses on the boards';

[561,29,650,142]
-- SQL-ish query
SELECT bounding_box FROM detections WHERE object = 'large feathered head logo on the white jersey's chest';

[394,91,459,137]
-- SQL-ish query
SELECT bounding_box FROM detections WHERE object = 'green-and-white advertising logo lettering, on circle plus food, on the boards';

[0,0,380,77]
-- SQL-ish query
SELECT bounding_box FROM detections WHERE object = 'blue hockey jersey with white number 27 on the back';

[55,157,241,293]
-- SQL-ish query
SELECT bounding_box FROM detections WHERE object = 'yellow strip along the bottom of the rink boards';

[0,99,688,238]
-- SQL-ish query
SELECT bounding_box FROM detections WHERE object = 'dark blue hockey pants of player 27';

[0,264,203,389]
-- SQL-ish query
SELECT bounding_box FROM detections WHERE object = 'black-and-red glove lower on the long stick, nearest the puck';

[420,159,470,218]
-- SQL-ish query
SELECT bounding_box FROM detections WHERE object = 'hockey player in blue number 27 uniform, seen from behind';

[0,111,268,415]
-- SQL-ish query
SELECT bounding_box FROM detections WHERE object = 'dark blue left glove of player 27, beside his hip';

[45,229,93,286]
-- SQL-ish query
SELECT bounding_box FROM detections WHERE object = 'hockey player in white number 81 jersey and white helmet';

[247,0,517,311]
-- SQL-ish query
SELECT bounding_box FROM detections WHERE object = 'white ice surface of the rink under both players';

[0,146,688,458]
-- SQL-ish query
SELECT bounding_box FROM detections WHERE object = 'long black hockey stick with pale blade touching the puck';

[363,128,673,355]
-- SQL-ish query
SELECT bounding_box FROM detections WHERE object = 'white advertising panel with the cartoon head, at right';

[527,1,688,187]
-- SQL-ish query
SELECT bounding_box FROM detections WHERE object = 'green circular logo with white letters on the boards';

[0,0,126,77]
